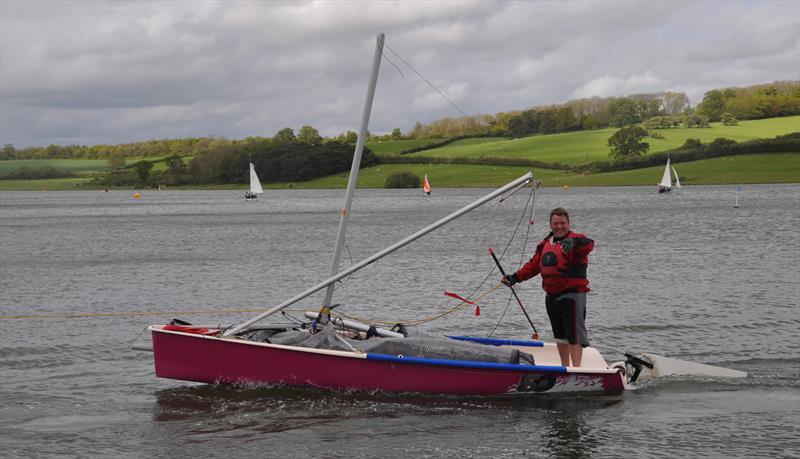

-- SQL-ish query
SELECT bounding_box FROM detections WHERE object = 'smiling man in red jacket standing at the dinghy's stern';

[502,207,594,367]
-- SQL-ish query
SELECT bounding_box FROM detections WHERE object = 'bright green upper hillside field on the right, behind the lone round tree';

[412,116,800,164]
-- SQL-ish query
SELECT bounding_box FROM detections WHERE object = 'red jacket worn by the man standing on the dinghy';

[514,231,594,295]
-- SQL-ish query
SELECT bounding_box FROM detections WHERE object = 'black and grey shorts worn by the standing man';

[544,293,589,347]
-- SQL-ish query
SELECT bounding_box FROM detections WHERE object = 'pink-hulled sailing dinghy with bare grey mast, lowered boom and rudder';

[135,34,744,395]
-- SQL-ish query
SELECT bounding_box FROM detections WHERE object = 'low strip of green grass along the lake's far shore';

[0,152,800,192]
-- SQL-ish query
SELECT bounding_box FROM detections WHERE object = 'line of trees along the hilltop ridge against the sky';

[0,81,800,163]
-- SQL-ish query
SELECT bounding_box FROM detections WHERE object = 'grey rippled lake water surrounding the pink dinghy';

[0,184,800,458]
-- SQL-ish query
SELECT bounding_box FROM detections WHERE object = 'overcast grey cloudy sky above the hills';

[0,0,800,148]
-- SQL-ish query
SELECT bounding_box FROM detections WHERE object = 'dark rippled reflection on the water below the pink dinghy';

[153,385,624,457]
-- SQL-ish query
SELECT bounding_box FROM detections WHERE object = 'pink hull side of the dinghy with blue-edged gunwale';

[151,326,625,395]
